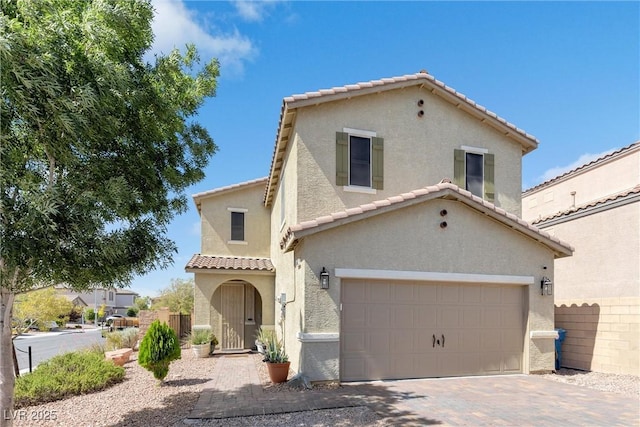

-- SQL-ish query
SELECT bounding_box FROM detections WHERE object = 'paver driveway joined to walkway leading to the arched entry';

[189,354,640,426]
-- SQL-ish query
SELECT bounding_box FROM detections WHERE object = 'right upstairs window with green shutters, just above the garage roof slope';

[453,147,495,202]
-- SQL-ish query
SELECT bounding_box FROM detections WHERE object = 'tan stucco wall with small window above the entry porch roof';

[200,183,271,257]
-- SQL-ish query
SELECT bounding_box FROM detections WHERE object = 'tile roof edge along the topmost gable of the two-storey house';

[264,71,538,206]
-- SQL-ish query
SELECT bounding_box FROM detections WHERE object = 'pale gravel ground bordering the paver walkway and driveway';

[14,348,640,427]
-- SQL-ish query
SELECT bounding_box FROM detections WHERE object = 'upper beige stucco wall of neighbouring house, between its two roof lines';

[522,145,640,222]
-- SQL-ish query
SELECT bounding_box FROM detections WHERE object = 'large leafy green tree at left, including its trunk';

[0,0,218,423]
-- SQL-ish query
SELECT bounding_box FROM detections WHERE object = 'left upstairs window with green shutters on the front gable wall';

[336,129,384,190]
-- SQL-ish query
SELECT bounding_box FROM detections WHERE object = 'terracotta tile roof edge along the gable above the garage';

[280,180,573,257]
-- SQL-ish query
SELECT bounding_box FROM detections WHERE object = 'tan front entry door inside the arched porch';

[220,283,244,350]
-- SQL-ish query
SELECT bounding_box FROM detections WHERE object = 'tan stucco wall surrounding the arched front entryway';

[193,272,275,345]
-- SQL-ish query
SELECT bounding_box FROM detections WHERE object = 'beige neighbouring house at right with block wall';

[522,142,640,375]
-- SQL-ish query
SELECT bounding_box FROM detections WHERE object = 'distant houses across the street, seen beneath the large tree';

[55,285,138,316]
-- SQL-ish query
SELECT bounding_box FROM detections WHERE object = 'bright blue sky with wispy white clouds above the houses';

[131,0,640,296]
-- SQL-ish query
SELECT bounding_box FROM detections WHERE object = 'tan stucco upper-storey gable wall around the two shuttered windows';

[288,87,522,222]
